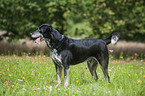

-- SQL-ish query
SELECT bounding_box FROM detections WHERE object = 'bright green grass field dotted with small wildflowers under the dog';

[0,55,145,96]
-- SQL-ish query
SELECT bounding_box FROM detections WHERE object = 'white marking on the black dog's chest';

[50,49,62,66]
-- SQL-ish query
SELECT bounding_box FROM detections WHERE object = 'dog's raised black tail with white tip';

[103,32,120,45]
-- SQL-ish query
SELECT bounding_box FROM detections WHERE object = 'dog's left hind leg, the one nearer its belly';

[87,59,98,81]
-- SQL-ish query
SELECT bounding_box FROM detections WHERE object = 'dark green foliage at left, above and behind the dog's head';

[0,0,65,40]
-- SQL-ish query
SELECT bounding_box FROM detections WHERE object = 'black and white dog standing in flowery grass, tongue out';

[31,24,120,86]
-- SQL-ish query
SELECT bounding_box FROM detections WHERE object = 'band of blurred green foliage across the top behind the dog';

[0,0,145,41]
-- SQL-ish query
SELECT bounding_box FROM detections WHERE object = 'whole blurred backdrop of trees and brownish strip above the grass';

[0,0,145,59]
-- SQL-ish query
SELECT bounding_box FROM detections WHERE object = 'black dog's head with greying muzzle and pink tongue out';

[30,24,53,44]
